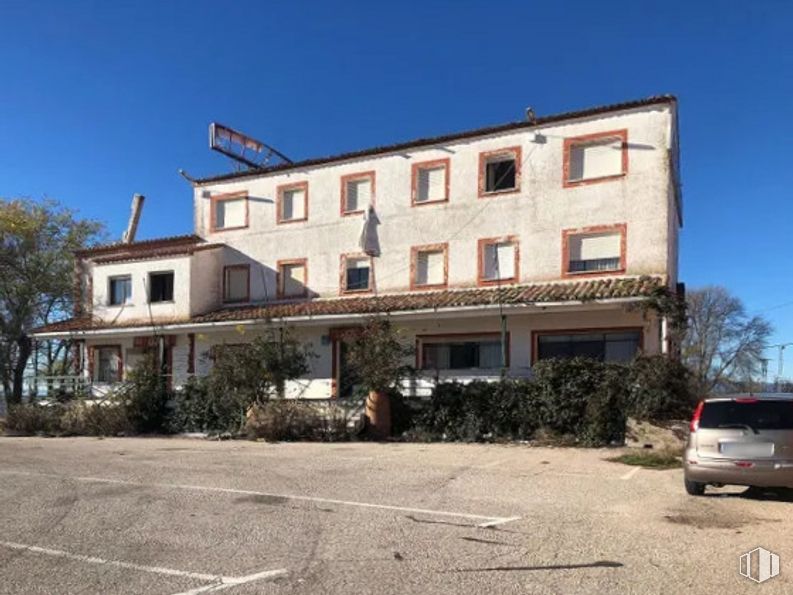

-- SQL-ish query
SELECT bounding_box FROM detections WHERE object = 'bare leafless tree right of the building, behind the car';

[682,286,773,396]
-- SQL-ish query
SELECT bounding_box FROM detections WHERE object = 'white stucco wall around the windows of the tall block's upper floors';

[195,105,677,300]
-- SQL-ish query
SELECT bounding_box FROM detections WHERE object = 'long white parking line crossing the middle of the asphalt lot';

[0,471,521,526]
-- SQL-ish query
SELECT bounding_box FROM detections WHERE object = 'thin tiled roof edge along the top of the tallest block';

[193,95,677,185]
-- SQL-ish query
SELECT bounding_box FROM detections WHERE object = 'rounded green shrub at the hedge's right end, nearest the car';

[626,355,696,421]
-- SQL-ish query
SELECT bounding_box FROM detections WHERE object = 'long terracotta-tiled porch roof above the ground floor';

[33,276,664,336]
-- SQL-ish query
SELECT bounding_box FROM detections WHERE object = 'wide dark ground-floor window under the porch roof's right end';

[535,329,642,362]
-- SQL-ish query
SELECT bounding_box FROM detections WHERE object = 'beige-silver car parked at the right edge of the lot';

[683,395,793,496]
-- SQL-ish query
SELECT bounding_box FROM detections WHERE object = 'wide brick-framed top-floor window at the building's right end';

[564,130,628,186]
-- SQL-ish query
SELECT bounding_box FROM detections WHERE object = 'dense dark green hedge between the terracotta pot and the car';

[406,356,692,446]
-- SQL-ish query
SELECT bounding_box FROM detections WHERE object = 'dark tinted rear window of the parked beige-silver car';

[699,400,793,430]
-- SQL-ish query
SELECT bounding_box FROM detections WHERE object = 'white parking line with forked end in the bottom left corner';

[0,541,286,595]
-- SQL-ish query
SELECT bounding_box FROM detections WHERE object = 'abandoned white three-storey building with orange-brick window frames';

[36,96,682,398]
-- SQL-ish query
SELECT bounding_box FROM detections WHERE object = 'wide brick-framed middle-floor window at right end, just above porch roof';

[563,225,626,276]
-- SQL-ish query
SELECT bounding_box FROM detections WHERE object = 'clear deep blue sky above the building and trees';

[0,0,793,374]
